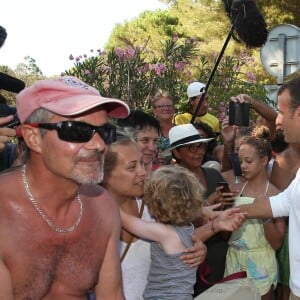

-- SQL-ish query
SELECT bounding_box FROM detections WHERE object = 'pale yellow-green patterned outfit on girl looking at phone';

[224,184,278,295]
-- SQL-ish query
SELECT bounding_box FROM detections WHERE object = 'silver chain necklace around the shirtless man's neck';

[21,165,83,233]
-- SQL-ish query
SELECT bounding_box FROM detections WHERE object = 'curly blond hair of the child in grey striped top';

[143,165,204,226]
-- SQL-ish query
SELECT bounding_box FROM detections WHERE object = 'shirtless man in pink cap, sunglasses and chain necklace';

[0,77,129,300]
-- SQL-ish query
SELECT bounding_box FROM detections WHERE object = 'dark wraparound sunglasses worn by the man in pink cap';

[28,121,116,144]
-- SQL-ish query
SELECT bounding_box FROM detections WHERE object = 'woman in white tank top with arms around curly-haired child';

[103,132,242,300]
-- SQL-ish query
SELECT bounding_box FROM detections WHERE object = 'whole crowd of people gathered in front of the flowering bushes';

[0,77,300,300]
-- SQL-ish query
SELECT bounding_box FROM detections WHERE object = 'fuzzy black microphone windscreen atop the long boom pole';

[224,0,268,47]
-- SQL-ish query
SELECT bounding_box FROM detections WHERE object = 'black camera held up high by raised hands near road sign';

[228,101,250,126]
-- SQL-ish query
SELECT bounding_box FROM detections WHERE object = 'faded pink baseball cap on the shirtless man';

[16,76,130,123]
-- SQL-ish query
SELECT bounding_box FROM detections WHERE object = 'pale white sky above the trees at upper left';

[0,0,166,76]
